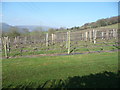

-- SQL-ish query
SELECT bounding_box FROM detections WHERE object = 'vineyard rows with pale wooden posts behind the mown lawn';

[0,28,119,58]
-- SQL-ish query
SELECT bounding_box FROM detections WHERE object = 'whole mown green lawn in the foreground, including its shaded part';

[2,52,118,89]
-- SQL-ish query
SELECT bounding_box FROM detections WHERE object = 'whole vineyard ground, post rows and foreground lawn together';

[0,22,120,89]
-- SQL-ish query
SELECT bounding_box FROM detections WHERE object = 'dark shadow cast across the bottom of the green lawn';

[4,71,120,89]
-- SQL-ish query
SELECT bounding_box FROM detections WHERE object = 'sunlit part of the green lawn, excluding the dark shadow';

[2,52,118,88]
